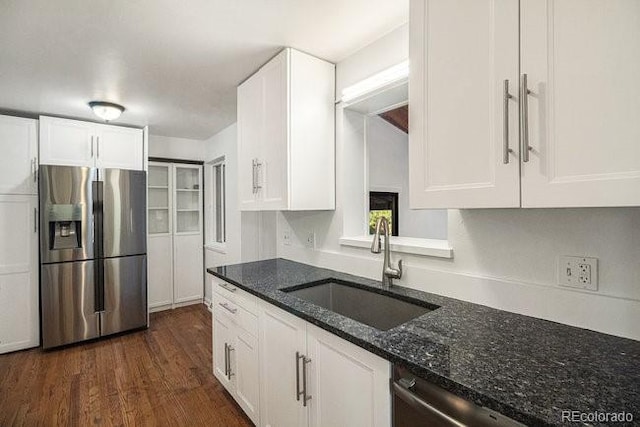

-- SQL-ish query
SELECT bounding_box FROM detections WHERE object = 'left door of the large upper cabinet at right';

[409,0,520,208]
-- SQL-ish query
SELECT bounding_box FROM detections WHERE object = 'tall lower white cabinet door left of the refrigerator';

[0,196,40,353]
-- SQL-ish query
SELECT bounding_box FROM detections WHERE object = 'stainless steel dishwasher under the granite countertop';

[391,365,524,427]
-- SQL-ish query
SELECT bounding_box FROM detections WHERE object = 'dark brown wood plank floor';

[0,305,252,426]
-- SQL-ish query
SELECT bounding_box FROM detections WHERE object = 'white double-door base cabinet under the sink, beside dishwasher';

[259,301,391,427]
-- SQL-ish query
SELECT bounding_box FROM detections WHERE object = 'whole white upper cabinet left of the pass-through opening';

[238,48,335,211]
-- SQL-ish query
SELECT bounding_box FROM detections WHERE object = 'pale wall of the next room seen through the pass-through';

[368,116,447,239]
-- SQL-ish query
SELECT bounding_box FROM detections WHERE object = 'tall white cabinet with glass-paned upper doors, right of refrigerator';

[147,162,204,311]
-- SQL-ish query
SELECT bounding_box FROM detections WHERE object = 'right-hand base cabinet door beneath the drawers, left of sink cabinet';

[231,328,260,425]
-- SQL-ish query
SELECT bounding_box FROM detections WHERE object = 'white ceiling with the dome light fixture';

[0,0,408,139]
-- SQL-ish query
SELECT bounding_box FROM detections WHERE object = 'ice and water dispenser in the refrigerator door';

[48,203,82,250]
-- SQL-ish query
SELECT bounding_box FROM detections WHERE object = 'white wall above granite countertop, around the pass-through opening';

[277,25,640,339]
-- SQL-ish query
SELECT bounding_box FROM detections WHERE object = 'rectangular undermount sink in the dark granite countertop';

[283,281,438,331]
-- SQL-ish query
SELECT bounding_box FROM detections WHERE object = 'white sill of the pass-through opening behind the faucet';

[339,236,453,258]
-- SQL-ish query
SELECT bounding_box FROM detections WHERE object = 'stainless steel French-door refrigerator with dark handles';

[39,165,148,349]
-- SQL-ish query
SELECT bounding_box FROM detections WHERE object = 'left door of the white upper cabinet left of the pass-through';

[238,74,264,211]
